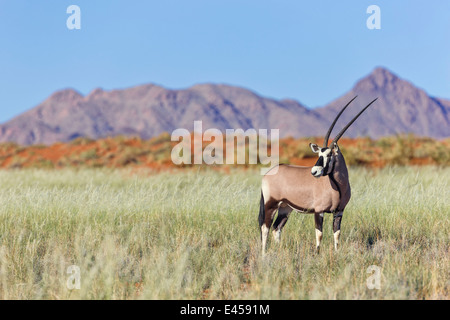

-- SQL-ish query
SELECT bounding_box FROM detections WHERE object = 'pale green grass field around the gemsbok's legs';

[0,167,450,299]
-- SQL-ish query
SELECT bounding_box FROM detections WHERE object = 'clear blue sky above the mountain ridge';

[0,0,450,123]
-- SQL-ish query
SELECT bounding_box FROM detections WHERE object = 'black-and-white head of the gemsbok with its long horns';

[309,97,378,178]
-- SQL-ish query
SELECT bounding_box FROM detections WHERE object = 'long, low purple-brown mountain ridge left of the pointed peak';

[0,84,325,144]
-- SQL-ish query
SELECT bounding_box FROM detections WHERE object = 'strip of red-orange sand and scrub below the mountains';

[0,134,450,172]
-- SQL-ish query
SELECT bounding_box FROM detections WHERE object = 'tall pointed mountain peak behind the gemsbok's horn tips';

[315,68,450,139]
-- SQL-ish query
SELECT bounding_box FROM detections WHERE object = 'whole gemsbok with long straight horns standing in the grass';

[258,97,378,255]
